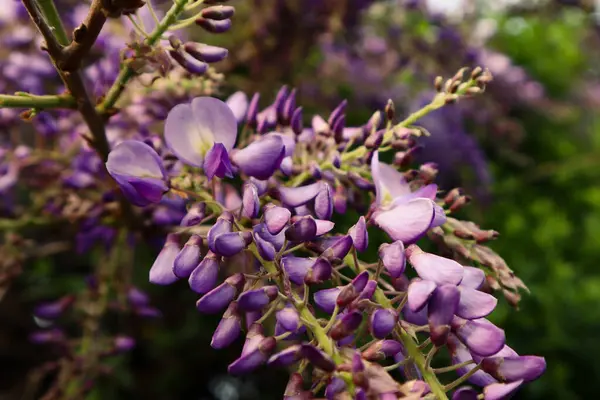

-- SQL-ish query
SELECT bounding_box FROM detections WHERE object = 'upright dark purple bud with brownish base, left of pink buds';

[428,285,460,347]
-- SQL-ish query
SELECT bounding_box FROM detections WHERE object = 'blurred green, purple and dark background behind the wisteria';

[0,0,600,400]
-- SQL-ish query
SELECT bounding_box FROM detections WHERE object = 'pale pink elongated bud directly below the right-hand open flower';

[406,244,463,285]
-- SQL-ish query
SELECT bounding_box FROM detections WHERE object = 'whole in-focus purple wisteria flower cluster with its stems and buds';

[0,0,546,400]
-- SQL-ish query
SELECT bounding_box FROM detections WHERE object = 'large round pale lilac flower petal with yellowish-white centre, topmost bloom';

[165,97,237,170]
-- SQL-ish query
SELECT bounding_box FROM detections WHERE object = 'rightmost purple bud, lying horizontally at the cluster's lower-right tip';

[481,356,546,382]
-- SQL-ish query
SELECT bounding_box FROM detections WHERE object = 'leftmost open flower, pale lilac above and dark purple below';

[106,140,169,207]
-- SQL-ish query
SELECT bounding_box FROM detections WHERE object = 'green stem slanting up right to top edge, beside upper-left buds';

[96,0,188,114]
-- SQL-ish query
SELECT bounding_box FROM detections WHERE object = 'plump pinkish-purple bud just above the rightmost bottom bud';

[452,316,506,356]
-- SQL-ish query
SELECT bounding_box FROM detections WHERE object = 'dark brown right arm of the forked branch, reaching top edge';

[58,0,107,71]
